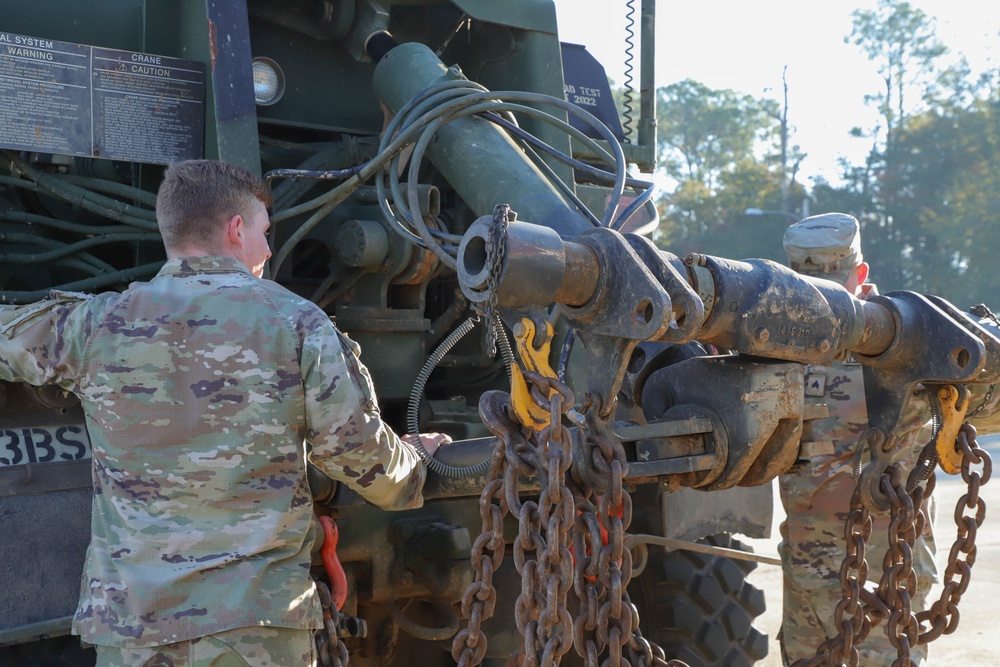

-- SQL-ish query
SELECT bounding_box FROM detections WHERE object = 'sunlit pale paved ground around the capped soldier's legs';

[744,436,1000,667]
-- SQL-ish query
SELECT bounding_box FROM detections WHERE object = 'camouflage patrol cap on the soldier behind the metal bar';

[784,213,862,283]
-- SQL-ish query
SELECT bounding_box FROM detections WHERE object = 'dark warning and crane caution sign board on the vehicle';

[0,32,205,164]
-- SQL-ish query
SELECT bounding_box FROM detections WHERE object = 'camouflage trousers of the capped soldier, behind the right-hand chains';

[778,498,938,667]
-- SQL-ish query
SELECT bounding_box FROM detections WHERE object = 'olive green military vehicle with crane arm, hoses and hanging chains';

[0,0,1000,667]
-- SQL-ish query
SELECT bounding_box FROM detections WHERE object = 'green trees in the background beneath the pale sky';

[654,0,1000,311]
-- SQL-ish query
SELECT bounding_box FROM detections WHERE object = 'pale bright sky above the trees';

[555,0,1000,187]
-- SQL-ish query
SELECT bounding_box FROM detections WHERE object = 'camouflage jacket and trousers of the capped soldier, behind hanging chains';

[778,354,938,667]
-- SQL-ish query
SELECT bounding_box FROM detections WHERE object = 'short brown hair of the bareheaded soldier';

[156,160,271,254]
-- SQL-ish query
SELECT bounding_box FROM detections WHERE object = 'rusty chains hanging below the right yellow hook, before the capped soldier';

[793,423,993,667]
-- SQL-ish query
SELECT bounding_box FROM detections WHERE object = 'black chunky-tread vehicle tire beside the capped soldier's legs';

[629,535,768,667]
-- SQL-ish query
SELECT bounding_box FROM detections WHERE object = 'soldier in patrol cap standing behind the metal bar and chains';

[778,213,938,667]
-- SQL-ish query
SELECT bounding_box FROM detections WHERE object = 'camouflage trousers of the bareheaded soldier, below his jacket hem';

[94,627,316,667]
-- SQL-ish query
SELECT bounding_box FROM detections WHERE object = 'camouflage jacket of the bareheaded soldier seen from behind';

[0,257,426,647]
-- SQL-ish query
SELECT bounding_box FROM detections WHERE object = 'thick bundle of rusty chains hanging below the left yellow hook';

[452,371,684,667]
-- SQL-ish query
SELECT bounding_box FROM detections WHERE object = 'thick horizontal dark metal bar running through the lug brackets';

[458,218,940,364]
